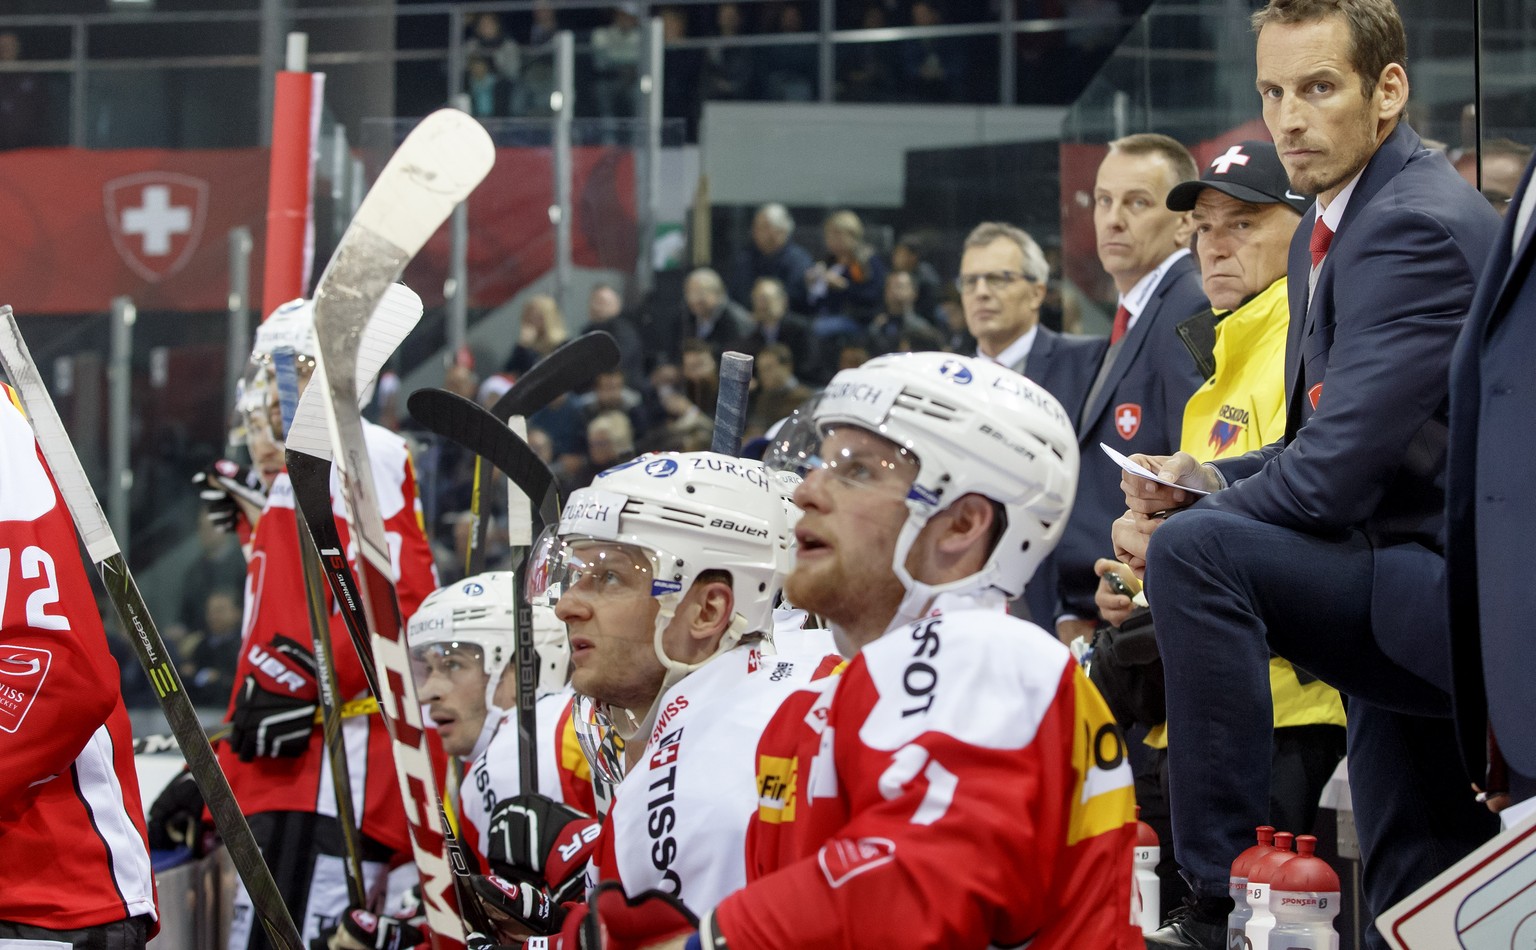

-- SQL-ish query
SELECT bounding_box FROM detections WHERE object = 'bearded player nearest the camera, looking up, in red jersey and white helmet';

[559,354,1141,950]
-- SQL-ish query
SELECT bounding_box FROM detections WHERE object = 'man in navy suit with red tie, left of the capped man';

[1055,134,1210,643]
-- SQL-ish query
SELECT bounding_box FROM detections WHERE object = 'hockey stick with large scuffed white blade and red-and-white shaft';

[315,109,495,947]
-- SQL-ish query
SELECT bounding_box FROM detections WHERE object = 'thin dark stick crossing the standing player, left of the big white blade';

[272,346,369,907]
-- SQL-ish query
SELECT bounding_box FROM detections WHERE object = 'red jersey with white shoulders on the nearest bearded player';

[714,595,1141,950]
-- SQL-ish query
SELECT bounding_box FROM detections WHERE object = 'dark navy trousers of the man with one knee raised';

[1147,509,1495,947]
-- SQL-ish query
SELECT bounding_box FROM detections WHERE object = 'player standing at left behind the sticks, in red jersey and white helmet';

[166,300,438,950]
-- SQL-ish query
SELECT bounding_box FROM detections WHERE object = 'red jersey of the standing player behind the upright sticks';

[218,424,436,852]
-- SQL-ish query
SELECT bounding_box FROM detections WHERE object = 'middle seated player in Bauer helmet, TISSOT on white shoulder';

[485,452,835,940]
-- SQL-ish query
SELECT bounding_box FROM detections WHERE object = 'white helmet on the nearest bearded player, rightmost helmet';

[765,352,1078,621]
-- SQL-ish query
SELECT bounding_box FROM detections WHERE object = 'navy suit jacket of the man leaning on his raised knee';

[1200,121,1498,694]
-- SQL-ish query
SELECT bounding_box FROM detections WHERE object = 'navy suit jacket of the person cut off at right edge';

[1445,153,1536,778]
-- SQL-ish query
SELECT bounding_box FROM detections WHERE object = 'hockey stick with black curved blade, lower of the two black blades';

[406,382,559,795]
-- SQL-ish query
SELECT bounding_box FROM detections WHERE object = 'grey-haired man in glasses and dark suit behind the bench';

[952,221,1107,629]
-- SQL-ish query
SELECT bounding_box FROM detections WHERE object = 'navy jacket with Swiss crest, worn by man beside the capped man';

[1054,255,1210,618]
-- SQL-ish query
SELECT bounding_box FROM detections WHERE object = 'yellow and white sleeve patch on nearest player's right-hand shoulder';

[1066,663,1137,845]
